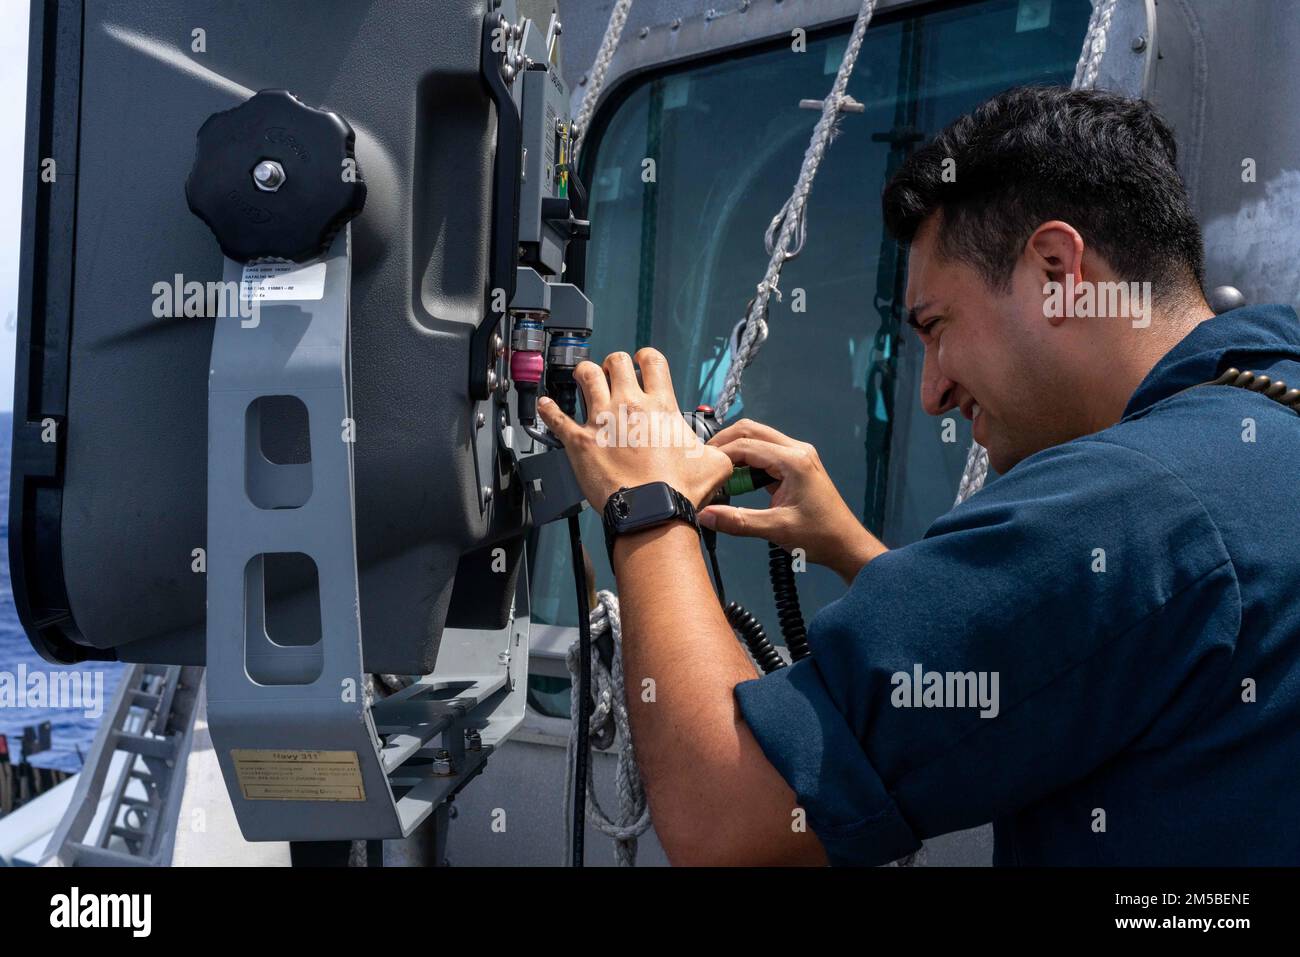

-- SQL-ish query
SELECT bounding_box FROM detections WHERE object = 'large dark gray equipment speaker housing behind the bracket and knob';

[9,0,548,675]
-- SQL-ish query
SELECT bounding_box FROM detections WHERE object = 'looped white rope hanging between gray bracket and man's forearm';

[564,592,650,867]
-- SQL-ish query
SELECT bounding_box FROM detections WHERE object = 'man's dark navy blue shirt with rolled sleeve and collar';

[736,306,1300,865]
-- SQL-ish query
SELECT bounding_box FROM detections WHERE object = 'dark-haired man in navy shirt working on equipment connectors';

[542,87,1300,865]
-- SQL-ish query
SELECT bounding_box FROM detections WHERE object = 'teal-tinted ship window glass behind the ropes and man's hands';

[532,0,1089,702]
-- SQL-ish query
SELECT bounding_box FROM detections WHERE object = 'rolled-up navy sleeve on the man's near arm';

[736,438,1242,865]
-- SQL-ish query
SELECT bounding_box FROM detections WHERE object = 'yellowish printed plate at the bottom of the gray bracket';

[230,748,365,801]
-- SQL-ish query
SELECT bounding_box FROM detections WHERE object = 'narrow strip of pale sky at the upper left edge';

[0,0,27,411]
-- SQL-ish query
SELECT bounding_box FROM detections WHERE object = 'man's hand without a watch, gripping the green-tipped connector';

[699,419,888,584]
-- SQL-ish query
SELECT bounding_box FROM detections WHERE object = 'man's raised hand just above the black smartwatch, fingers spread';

[537,348,732,511]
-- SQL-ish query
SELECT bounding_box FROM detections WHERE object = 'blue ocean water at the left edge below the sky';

[0,412,125,771]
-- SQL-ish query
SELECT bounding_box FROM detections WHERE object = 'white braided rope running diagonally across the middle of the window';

[714,0,876,419]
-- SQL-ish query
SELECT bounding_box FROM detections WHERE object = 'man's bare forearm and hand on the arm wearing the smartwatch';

[537,348,821,865]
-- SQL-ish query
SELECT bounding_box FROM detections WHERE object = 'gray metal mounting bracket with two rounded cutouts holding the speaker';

[207,226,528,840]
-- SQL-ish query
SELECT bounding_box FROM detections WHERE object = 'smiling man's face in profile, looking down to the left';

[906,215,1087,472]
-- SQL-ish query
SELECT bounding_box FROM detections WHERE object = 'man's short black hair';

[881,86,1205,300]
